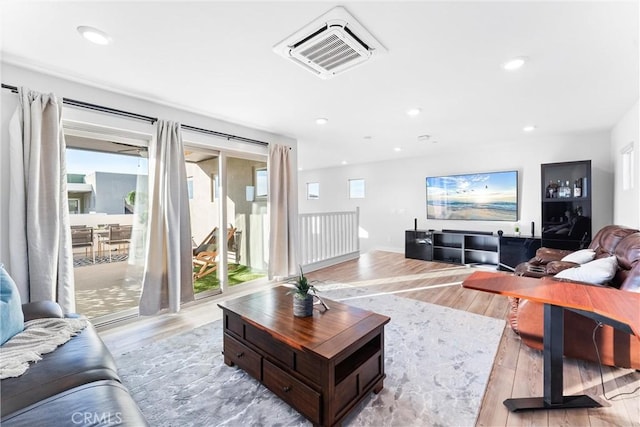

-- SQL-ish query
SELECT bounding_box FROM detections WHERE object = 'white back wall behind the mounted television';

[298,132,613,252]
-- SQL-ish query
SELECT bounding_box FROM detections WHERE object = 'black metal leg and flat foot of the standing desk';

[504,304,601,412]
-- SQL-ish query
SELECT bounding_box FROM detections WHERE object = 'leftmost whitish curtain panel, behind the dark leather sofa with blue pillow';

[8,88,75,313]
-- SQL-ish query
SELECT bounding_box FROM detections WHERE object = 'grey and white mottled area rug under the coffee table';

[116,288,505,426]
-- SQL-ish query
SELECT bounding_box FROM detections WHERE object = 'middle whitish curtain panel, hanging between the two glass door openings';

[140,120,194,315]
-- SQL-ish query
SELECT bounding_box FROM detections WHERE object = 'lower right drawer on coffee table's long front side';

[262,360,321,424]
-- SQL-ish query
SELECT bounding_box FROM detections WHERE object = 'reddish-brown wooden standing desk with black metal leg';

[462,271,640,412]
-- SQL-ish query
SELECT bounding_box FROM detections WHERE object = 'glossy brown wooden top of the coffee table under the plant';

[218,286,390,359]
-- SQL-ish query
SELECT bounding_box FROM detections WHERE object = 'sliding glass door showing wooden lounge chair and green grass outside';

[185,145,268,298]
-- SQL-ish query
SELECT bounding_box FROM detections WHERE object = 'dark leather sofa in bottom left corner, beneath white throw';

[0,301,148,427]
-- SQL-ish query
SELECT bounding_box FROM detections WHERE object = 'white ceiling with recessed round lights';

[1,0,639,169]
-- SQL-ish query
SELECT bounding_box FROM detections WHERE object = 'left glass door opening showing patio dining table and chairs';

[66,135,148,324]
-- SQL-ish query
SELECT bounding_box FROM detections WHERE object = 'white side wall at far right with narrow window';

[611,102,640,229]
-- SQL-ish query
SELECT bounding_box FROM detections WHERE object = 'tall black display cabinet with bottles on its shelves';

[541,160,592,250]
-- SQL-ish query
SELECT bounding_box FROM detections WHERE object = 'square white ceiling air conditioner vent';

[273,6,386,79]
